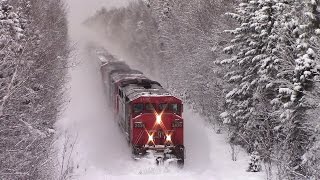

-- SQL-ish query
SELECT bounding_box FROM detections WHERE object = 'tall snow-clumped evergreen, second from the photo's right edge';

[264,0,318,177]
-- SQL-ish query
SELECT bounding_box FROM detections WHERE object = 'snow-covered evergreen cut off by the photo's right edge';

[288,0,320,178]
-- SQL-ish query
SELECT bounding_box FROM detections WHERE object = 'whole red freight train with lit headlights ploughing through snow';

[91,48,185,166]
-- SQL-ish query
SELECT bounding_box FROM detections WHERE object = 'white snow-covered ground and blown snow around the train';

[57,0,264,180]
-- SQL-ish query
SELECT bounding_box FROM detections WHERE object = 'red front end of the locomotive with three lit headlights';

[131,96,185,165]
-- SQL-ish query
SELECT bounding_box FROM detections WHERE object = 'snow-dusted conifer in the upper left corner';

[0,1,26,116]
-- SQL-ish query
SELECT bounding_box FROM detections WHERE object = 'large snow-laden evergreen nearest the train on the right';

[221,0,281,153]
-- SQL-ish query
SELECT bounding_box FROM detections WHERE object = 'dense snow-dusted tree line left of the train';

[0,0,69,179]
